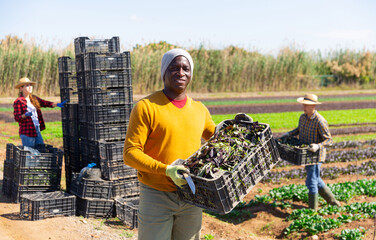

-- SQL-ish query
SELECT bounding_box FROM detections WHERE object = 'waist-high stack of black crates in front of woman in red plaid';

[3,144,63,203]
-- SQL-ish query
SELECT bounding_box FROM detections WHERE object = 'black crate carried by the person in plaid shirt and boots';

[276,138,322,166]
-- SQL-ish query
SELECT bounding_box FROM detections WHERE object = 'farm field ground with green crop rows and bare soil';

[0,90,376,240]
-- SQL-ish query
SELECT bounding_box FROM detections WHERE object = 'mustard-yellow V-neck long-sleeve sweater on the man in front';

[123,91,215,192]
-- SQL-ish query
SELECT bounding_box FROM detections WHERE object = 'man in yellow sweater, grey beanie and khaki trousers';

[124,49,216,240]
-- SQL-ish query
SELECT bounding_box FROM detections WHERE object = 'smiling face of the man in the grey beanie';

[164,56,191,94]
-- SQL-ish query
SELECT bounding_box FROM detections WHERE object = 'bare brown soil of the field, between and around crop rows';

[0,91,376,240]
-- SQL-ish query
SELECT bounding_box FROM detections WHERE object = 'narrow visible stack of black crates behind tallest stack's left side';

[58,56,82,190]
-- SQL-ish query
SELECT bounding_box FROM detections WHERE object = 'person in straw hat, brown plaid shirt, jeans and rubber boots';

[282,94,340,210]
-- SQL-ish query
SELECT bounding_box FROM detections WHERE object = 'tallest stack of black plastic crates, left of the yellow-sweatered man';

[75,37,139,217]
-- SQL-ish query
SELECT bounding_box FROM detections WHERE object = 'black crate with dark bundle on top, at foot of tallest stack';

[70,174,112,200]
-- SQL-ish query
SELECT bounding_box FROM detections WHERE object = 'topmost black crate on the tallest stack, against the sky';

[74,37,120,55]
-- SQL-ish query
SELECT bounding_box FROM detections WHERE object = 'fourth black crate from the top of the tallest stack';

[78,86,133,106]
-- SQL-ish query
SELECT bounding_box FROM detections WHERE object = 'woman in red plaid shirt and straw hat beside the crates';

[13,77,66,148]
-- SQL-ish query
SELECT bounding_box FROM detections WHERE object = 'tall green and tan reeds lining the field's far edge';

[0,36,376,96]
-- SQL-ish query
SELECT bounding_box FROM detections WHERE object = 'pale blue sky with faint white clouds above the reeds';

[0,0,376,52]
